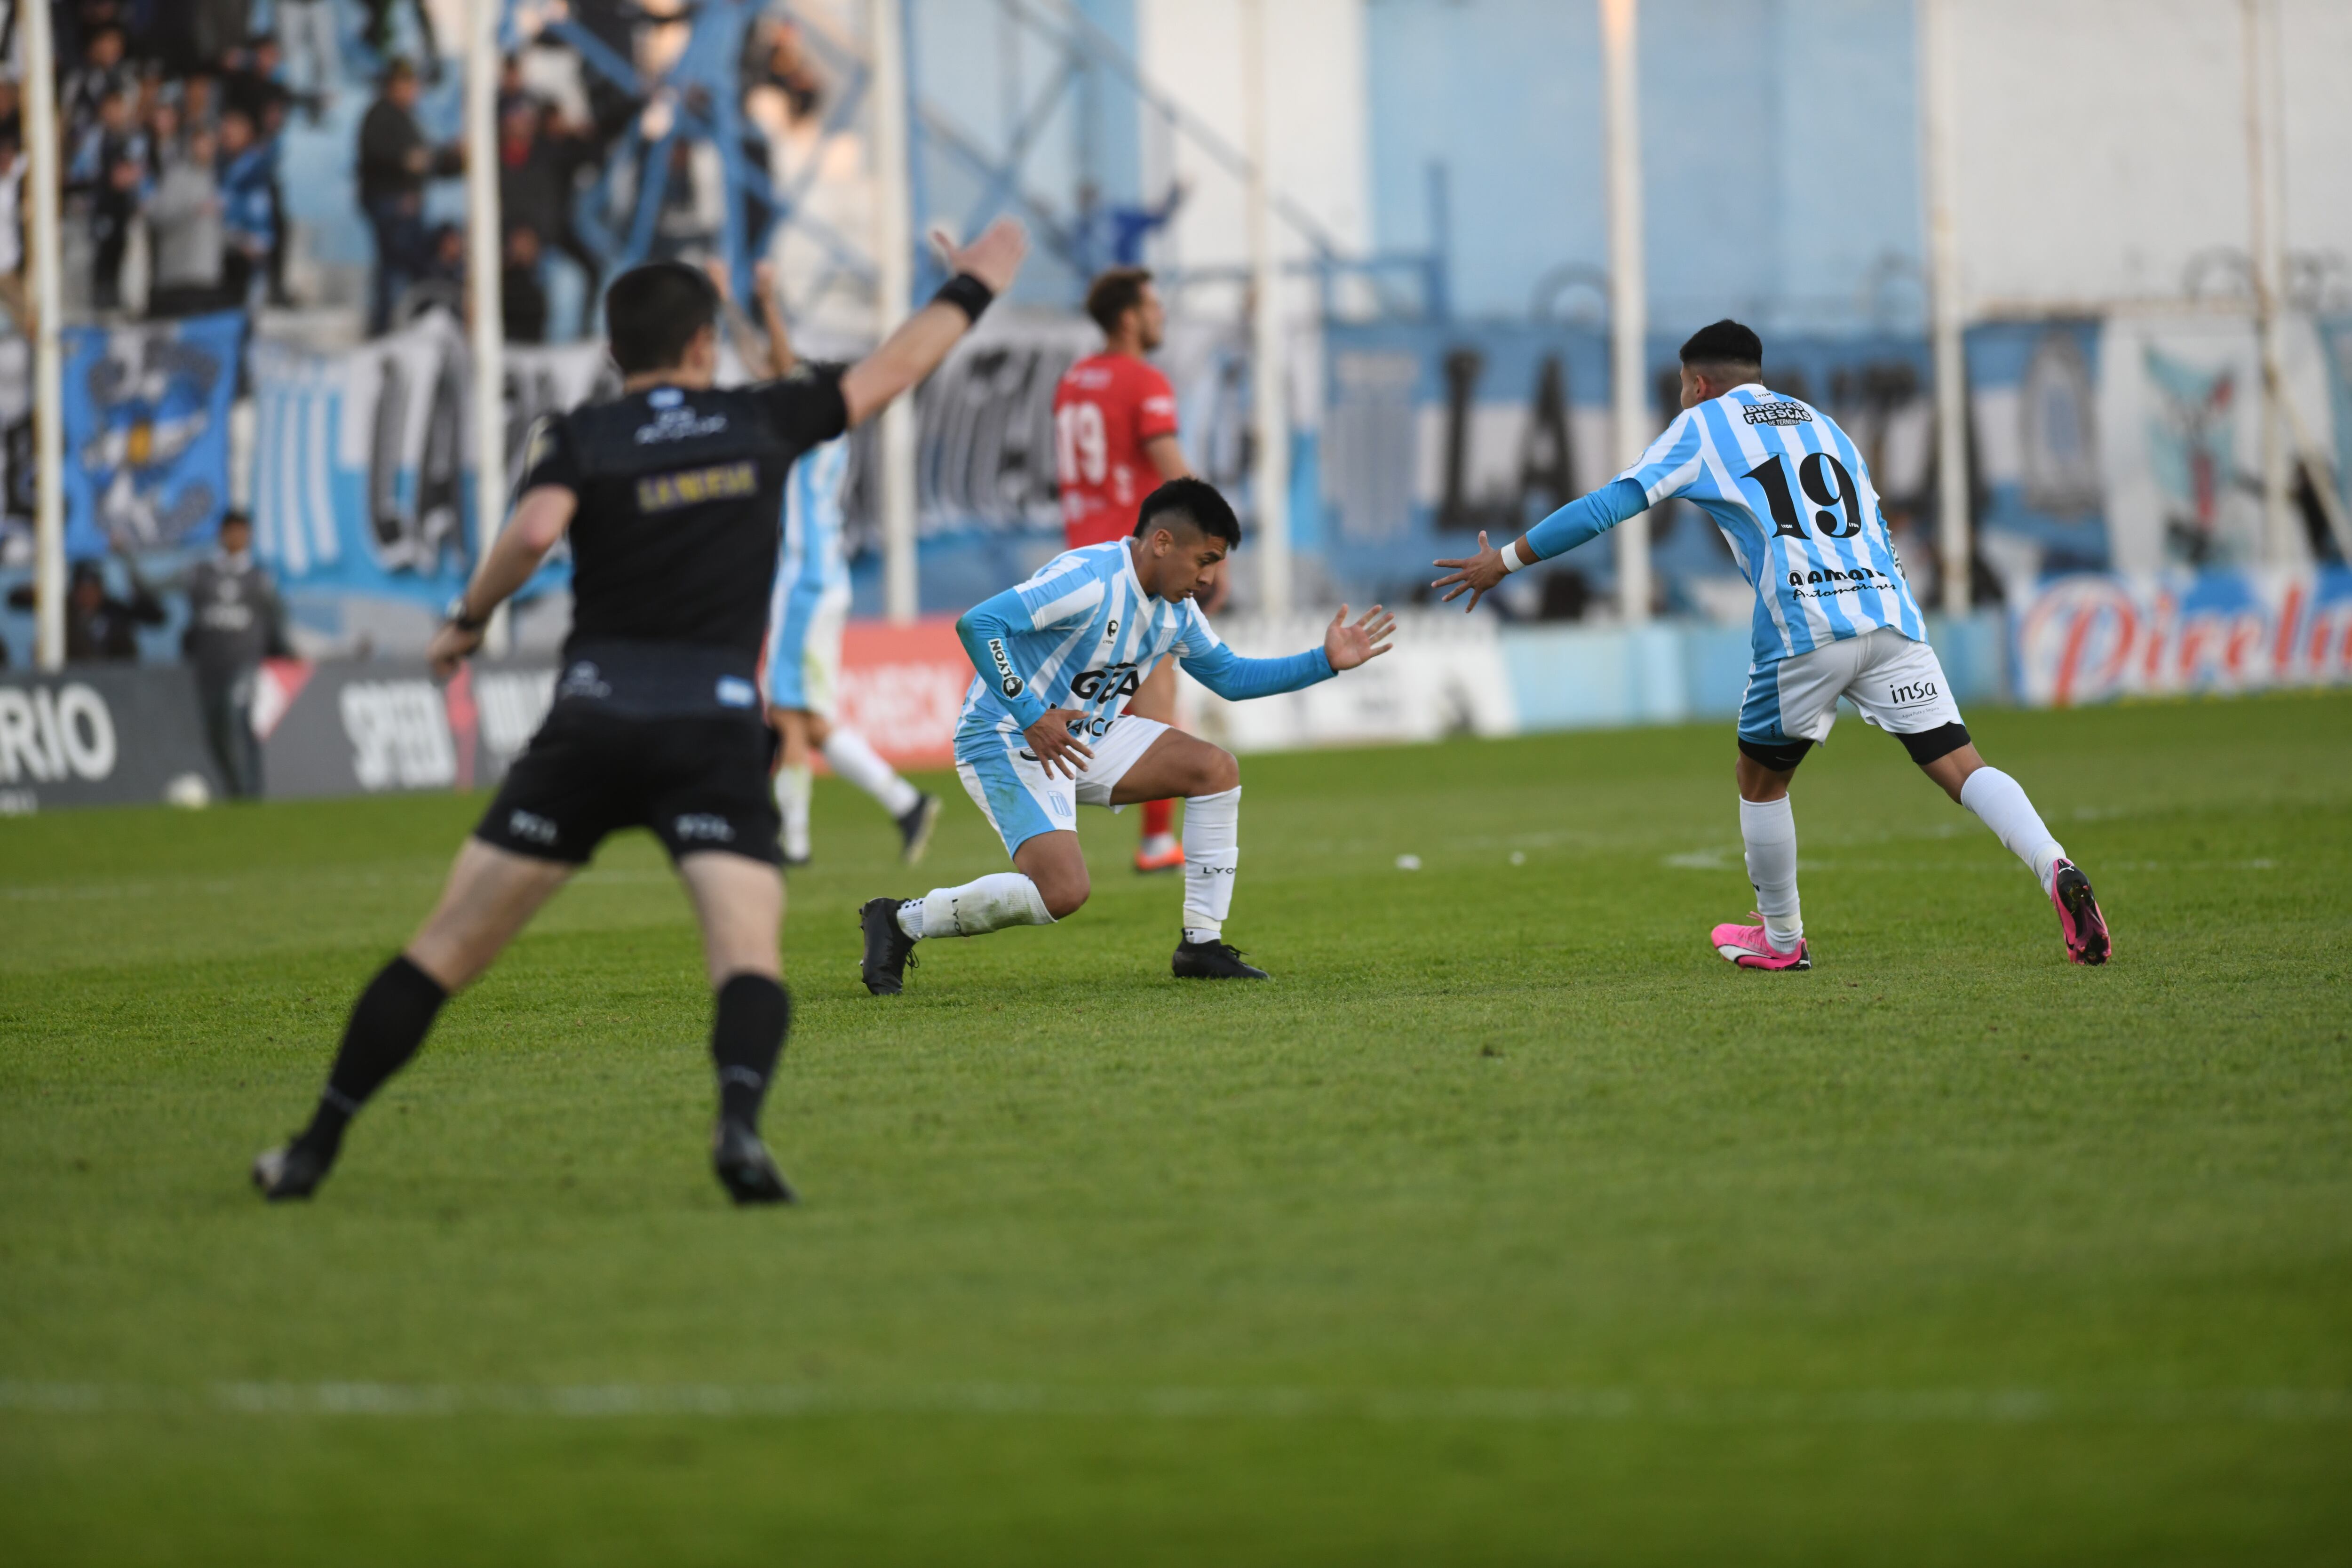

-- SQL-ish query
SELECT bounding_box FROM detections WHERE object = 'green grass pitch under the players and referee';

[0,696,2352,1566]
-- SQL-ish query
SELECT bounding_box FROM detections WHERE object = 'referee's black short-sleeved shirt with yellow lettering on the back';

[522,367,849,670]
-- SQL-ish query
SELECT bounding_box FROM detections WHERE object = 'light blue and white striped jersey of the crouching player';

[955,538,1331,757]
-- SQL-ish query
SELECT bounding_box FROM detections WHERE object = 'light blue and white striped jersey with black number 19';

[1618,381,1926,668]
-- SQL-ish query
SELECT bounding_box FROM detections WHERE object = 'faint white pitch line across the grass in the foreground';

[0,1380,2352,1427]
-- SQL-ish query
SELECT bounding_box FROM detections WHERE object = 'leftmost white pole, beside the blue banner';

[16,2,66,670]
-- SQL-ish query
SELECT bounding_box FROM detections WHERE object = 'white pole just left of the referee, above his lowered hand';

[466,0,513,656]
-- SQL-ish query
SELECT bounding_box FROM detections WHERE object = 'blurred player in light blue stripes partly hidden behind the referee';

[708,263,938,865]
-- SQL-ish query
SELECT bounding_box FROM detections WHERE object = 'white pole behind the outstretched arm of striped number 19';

[1602,0,1651,621]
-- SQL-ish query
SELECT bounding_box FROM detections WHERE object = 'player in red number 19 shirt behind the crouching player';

[1054,266,1195,872]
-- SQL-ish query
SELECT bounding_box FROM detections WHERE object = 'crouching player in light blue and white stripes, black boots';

[858,479,1395,997]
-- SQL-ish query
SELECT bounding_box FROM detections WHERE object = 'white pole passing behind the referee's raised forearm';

[866,0,922,623]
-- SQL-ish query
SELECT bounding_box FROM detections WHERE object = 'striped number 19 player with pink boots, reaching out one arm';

[1435,322,2110,971]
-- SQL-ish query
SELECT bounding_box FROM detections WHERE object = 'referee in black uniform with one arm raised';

[254,221,1028,1203]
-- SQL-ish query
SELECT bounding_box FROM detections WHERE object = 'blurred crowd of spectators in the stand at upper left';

[0,0,847,682]
